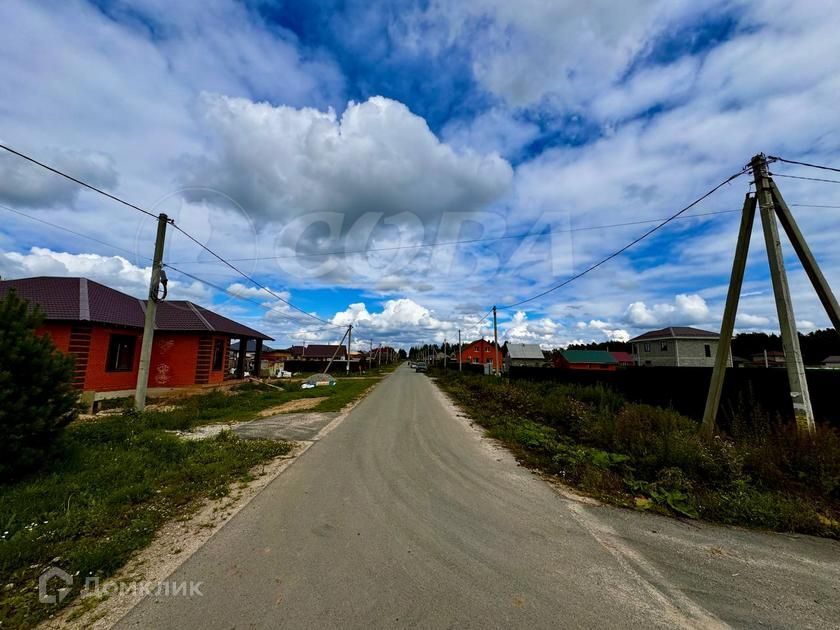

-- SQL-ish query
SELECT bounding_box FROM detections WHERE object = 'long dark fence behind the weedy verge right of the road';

[510,367,840,427]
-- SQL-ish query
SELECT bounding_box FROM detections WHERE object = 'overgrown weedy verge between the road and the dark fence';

[437,373,840,538]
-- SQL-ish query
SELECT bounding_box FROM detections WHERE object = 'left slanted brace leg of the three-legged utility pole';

[700,194,756,438]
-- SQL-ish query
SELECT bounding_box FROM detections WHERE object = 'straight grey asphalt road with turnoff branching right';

[120,368,840,630]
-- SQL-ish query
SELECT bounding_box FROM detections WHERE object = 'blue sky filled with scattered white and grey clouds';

[0,0,840,348]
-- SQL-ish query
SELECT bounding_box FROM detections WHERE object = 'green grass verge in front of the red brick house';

[0,378,378,628]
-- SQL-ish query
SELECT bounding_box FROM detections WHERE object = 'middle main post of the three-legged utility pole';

[752,154,815,432]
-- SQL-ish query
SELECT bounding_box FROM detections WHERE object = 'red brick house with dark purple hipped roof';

[0,277,271,398]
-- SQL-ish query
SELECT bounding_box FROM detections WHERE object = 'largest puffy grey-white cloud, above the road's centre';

[180,95,512,221]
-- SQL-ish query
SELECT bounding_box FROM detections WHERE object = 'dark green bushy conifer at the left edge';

[0,291,78,479]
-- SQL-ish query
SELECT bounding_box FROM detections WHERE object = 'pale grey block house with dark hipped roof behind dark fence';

[630,326,732,367]
